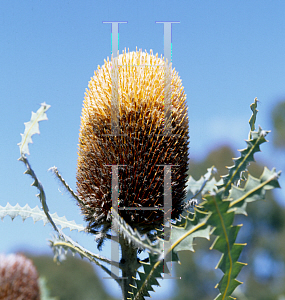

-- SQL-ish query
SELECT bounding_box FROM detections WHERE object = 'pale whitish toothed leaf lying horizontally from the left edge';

[0,203,85,232]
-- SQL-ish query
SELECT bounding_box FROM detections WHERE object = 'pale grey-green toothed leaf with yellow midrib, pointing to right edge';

[228,167,281,215]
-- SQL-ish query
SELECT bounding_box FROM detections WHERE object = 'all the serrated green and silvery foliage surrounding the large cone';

[0,99,281,300]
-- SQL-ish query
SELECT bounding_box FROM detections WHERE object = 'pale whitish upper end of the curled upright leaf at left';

[18,102,50,156]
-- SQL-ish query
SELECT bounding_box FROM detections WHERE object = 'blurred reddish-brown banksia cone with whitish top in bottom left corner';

[0,254,40,300]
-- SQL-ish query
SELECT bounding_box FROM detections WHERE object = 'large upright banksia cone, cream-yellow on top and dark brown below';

[77,51,189,239]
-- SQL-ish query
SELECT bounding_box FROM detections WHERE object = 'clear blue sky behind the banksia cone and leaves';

[0,0,285,299]
